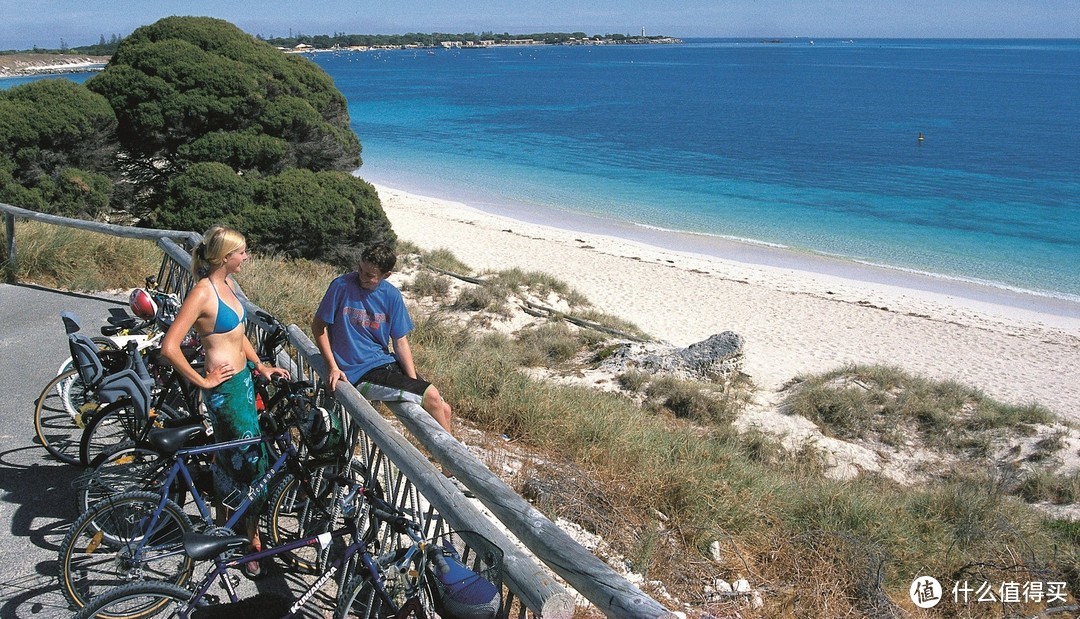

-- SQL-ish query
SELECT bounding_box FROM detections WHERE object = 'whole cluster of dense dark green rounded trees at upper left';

[0,17,394,257]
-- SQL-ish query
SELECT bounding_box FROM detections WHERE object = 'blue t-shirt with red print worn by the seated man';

[315,271,413,383]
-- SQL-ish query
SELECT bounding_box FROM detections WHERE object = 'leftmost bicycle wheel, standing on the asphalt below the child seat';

[33,369,96,465]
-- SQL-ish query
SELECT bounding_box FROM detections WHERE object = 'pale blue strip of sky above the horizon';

[0,0,1080,49]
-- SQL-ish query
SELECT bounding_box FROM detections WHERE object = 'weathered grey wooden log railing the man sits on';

[0,203,672,618]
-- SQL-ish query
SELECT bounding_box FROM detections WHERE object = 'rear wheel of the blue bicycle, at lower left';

[59,492,193,608]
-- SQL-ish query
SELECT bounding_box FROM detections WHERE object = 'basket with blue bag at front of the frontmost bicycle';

[431,531,502,619]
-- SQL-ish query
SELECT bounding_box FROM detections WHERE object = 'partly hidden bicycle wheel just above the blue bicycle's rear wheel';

[72,444,169,513]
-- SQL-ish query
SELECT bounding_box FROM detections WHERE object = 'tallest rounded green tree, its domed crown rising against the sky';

[86,17,361,208]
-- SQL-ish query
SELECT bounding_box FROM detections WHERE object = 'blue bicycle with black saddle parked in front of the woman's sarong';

[59,381,353,607]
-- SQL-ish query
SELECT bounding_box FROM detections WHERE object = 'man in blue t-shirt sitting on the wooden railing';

[311,244,453,434]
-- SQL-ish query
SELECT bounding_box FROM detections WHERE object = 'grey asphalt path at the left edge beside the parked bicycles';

[0,284,325,619]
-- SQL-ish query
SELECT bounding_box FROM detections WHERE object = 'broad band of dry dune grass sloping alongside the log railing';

[406,302,1080,617]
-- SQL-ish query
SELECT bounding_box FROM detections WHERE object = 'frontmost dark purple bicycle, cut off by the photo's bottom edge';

[76,485,502,619]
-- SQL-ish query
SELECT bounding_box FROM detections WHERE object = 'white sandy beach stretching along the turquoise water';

[377,186,1080,420]
